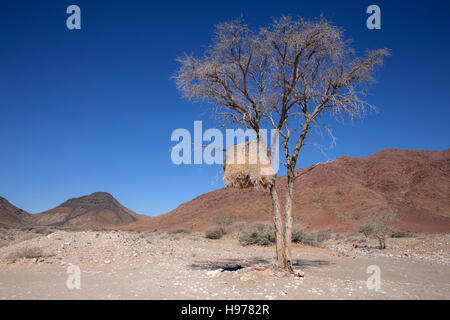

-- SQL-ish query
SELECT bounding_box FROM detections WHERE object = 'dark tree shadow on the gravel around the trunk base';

[189,258,332,272]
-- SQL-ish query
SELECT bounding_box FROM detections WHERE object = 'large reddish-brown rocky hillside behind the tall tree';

[121,149,450,232]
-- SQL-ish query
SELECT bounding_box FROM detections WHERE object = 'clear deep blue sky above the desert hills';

[0,0,450,215]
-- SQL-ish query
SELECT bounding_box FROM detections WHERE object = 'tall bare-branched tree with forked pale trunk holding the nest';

[175,16,389,272]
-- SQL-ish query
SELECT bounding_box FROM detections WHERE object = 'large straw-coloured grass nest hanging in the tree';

[223,140,276,189]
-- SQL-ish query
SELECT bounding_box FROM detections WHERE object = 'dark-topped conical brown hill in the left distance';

[33,192,139,229]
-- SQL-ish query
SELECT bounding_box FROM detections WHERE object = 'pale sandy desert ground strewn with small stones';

[0,229,450,299]
